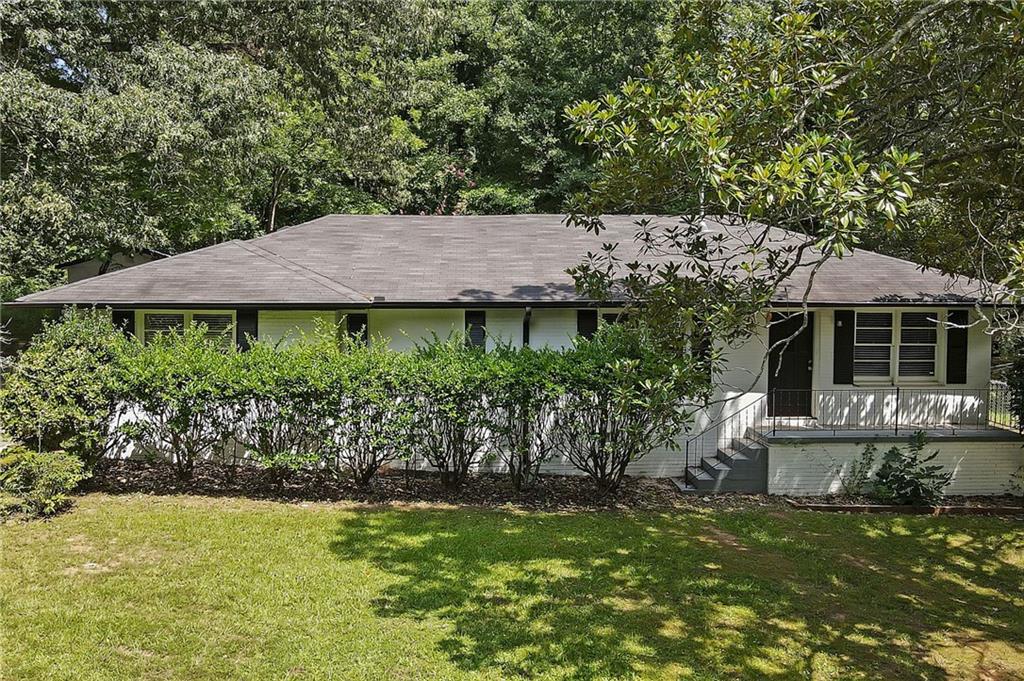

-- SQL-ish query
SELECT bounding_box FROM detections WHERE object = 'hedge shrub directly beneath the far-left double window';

[118,325,233,479]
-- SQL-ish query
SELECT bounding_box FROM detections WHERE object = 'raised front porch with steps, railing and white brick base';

[677,382,1024,496]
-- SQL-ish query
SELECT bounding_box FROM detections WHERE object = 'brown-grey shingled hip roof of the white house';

[8,215,978,308]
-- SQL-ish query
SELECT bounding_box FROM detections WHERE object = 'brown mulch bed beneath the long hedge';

[83,460,784,510]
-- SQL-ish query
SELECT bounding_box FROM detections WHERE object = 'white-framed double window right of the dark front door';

[853,311,939,382]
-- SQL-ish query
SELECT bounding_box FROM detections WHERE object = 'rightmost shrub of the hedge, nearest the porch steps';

[553,325,698,495]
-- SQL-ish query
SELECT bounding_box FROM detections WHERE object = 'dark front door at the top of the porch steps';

[768,312,814,416]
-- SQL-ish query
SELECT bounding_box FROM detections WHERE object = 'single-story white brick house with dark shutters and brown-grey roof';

[12,215,1024,495]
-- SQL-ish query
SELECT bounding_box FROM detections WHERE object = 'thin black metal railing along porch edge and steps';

[684,382,1024,483]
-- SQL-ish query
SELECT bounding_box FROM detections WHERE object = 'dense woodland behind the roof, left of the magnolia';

[0,0,660,299]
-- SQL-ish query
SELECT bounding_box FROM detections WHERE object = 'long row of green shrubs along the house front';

[0,312,699,494]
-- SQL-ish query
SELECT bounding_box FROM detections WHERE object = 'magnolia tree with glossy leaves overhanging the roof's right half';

[567,10,918,390]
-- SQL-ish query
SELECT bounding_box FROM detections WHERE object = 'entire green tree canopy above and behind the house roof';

[0,0,1024,315]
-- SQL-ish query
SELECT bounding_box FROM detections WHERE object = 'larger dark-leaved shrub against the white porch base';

[871,431,953,505]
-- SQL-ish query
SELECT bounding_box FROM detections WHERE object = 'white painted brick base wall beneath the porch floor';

[768,438,1024,497]
